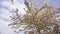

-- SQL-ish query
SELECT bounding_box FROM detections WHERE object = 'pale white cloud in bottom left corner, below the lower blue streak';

[0,19,17,34]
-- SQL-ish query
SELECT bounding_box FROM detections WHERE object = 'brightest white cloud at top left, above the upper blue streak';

[2,0,26,15]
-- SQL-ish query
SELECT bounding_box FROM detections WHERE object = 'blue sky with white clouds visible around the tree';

[0,0,60,34]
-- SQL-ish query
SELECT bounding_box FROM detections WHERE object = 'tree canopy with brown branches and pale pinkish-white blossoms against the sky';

[9,0,60,34]
